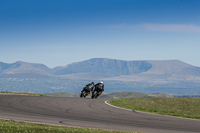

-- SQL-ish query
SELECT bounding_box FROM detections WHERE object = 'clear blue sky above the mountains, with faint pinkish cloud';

[0,0,200,68]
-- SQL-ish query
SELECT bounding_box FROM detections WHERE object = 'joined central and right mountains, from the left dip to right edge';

[54,58,200,84]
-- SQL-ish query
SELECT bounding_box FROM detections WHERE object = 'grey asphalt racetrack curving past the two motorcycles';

[0,95,200,133]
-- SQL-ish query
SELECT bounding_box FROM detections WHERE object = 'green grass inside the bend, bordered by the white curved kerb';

[108,98,200,119]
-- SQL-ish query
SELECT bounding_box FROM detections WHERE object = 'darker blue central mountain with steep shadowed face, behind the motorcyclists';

[55,58,152,78]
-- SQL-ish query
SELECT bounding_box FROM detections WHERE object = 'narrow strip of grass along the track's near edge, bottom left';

[0,120,137,133]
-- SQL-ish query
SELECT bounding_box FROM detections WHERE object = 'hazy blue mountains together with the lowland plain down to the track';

[0,58,200,94]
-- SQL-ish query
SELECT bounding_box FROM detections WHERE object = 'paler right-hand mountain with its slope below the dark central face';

[103,60,200,84]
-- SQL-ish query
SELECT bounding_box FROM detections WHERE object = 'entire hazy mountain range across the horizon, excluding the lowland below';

[0,58,200,83]
